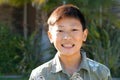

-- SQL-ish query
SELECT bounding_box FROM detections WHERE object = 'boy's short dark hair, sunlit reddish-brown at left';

[48,4,86,31]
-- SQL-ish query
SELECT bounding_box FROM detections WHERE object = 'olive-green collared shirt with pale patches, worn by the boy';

[29,52,112,80]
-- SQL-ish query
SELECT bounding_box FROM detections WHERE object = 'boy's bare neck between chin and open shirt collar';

[59,53,81,74]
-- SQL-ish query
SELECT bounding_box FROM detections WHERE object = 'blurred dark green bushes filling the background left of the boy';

[0,23,43,75]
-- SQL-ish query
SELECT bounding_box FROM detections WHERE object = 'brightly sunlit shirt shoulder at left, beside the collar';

[29,60,52,80]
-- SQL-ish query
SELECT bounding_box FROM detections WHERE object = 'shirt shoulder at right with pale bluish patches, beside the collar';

[87,58,110,78]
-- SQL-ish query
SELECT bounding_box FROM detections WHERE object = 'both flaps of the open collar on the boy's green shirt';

[51,51,90,73]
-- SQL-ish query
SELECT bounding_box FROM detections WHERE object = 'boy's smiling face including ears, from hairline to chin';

[48,17,88,55]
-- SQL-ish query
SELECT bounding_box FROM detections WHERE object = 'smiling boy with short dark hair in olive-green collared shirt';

[29,4,111,80]
